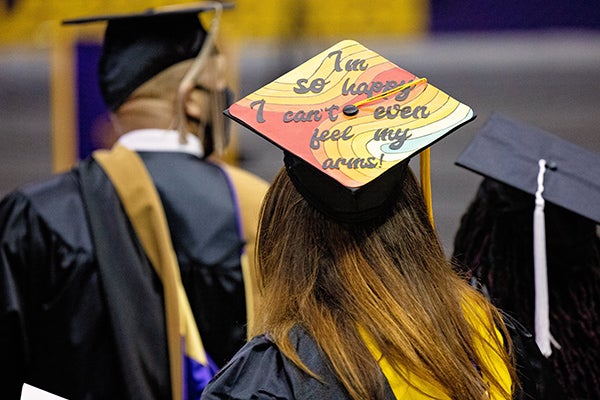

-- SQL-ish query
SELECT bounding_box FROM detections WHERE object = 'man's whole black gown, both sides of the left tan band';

[0,152,252,400]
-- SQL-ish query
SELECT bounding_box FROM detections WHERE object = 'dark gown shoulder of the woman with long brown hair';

[202,327,394,400]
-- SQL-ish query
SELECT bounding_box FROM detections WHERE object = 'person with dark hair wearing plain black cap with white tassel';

[454,113,600,399]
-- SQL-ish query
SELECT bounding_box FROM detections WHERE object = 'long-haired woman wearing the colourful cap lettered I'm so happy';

[202,40,516,400]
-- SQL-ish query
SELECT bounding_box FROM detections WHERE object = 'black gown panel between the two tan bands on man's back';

[139,152,246,366]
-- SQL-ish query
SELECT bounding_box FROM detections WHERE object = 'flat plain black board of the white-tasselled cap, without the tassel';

[456,113,600,223]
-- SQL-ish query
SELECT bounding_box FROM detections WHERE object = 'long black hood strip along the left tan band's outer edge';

[79,160,170,399]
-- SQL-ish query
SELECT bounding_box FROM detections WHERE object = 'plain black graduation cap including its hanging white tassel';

[456,113,600,356]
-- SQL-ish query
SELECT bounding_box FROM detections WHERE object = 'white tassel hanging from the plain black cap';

[533,159,552,357]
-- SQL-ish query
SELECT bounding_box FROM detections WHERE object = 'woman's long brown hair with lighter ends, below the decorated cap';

[255,169,515,400]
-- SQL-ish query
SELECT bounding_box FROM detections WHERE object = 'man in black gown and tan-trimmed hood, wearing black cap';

[0,2,267,400]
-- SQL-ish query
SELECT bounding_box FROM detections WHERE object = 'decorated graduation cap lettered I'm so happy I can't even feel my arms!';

[225,40,475,222]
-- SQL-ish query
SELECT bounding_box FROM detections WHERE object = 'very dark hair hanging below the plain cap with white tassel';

[453,178,600,399]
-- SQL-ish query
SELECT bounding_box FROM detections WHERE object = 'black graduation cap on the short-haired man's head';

[63,2,232,111]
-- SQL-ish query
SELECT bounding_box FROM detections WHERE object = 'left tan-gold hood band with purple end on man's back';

[93,145,218,400]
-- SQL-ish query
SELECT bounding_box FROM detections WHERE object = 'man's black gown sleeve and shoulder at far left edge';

[0,166,128,400]
